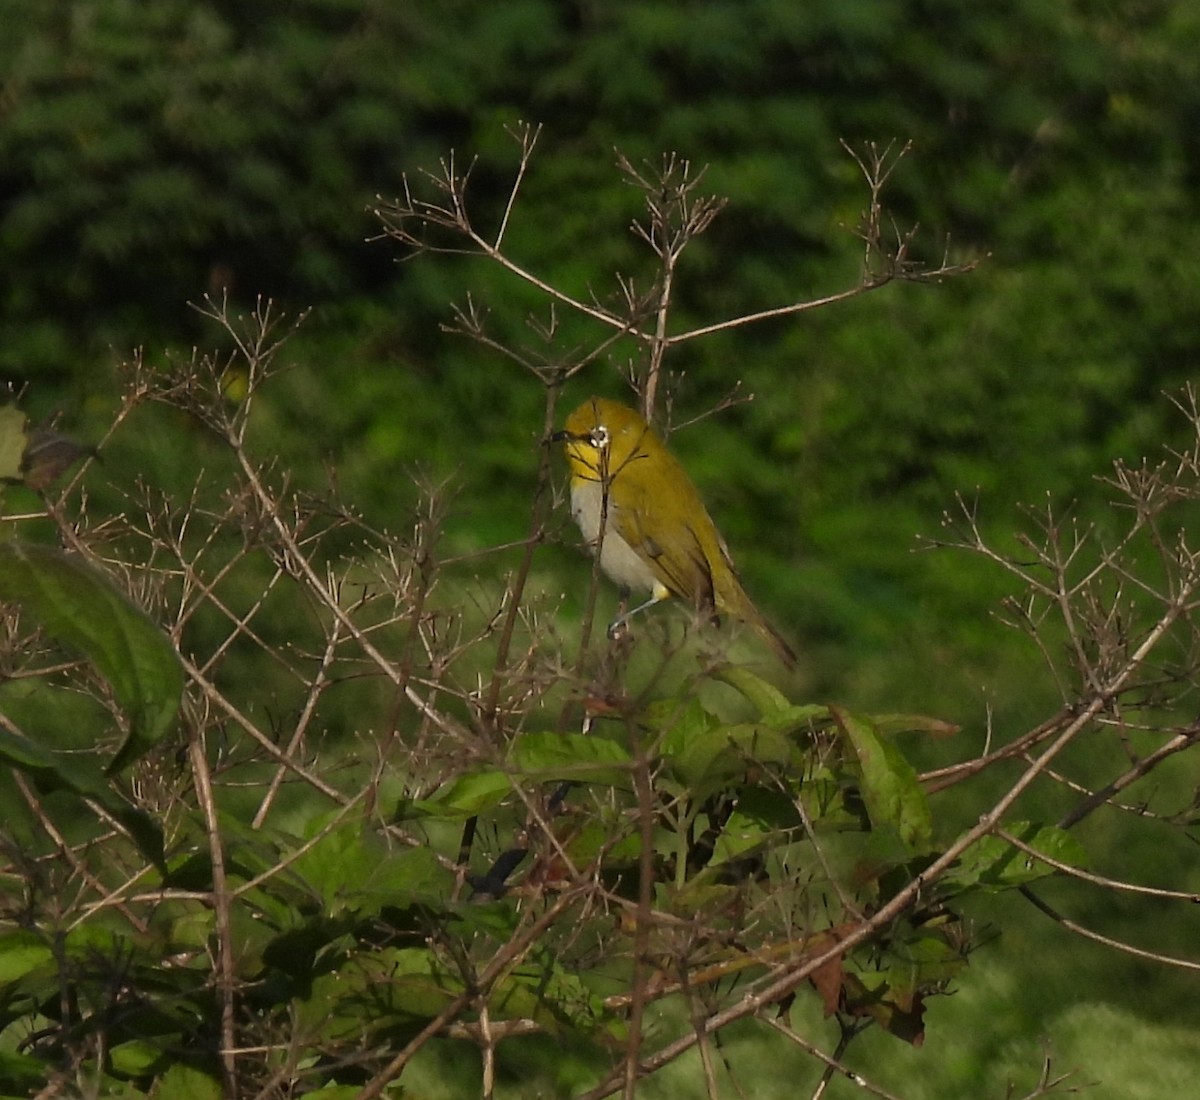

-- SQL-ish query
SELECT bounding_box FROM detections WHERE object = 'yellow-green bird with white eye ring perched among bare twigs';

[553,397,796,668]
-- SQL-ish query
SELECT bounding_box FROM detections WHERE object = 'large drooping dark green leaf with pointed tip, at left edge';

[0,541,184,771]
